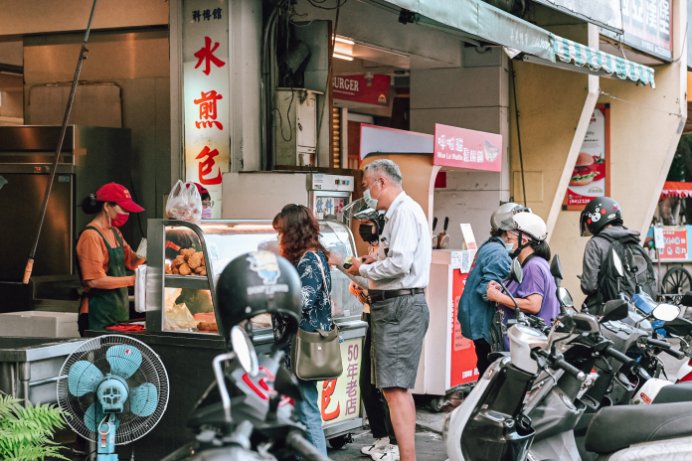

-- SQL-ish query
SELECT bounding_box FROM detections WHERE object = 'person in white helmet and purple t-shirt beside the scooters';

[487,213,560,347]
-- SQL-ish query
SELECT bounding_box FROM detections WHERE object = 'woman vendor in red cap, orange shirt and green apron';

[77,182,144,335]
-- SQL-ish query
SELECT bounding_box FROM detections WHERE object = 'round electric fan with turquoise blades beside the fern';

[58,335,168,461]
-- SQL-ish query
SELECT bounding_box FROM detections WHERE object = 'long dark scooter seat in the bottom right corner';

[585,402,692,454]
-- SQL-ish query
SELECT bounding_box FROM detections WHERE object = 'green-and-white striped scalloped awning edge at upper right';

[550,34,656,88]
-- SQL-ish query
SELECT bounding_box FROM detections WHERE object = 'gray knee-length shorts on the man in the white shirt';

[370,293,430,389]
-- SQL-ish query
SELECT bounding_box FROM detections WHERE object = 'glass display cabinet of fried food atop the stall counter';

[146,219,362,335]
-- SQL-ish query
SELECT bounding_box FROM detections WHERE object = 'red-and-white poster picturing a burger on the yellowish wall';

[567,104,610,210]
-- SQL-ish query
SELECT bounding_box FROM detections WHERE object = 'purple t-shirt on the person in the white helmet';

[505,256,560,326]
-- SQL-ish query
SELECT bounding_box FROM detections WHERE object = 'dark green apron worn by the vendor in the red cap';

[87,226,130,330]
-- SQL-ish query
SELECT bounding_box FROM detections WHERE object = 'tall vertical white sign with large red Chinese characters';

[182,0,230,218]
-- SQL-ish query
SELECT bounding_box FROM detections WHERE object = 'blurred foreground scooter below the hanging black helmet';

[162,326,329,461]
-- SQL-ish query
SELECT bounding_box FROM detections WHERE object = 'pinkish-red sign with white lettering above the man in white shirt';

[433,123,502,171]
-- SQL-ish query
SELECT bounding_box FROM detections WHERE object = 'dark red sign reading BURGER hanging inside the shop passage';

[332,74,392,106]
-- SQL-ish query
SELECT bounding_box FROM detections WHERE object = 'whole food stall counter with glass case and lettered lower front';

[136,219,367,459]
